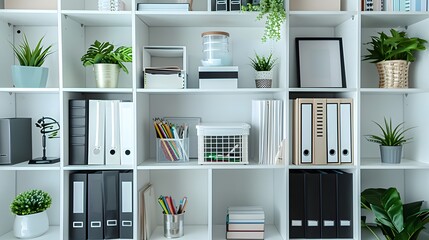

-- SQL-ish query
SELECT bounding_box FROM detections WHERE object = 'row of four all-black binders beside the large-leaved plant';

[289,170,353,239]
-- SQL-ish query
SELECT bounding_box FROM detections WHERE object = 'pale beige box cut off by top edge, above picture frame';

[290,0,341,11]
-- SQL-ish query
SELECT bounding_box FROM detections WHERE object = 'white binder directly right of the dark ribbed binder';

[88,100,105,165]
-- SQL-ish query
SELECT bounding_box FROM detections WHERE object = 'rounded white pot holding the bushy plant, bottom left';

[13,211,49,238]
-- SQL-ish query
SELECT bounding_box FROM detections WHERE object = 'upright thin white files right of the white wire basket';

[252,100,283,165]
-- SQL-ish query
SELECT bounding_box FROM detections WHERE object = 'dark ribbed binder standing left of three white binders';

[69,99,89,165]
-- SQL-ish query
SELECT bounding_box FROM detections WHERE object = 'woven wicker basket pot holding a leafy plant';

[376,60,410,88]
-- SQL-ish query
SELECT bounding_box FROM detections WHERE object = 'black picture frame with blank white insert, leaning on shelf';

[295,37,346,88]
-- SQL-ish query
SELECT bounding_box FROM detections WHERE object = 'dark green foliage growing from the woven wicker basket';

[363,29,427,63]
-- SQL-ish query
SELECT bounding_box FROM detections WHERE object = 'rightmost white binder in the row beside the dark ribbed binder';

[119,102,135,165]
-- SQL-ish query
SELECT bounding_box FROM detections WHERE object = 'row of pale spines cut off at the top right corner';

[362,0,428,12]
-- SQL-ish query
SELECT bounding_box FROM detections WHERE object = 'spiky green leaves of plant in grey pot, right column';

[366,118,412,146]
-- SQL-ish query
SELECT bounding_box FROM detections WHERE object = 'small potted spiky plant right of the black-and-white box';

[250,53,277,88]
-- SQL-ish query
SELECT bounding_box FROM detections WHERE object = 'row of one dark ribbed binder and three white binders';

[69,99,135,165]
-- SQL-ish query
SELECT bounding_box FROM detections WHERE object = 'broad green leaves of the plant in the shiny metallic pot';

[80,40,133,73]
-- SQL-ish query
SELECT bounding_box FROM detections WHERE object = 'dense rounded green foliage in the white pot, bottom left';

[10,189,52,215]
